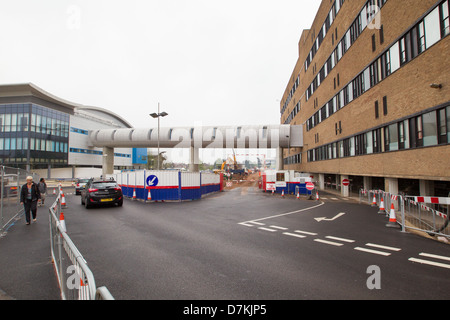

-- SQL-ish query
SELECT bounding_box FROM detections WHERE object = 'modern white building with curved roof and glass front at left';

[0,83,146,170]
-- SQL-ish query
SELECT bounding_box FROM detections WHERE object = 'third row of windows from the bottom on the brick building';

[305,0,387,101]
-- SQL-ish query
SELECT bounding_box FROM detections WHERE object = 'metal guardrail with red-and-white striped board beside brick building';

[359,189,450,237]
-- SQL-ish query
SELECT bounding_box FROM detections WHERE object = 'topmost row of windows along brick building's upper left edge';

[281,0,345,114]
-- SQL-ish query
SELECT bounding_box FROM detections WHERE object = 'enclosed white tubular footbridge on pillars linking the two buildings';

[88,125,303,174]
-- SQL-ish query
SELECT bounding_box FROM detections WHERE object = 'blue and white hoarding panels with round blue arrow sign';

[111,170,223,201]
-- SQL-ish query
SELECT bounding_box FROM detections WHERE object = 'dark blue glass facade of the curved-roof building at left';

[0,103,70,169]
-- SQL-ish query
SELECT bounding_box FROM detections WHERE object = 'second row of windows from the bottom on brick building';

[306,0,450,131]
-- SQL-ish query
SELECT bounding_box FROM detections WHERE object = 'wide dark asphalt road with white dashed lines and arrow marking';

[56,188,450,300]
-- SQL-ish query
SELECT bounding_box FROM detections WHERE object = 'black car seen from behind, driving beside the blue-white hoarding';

[81,179,123,209]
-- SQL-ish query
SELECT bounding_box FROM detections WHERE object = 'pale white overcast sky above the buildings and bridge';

[0,0,321,164]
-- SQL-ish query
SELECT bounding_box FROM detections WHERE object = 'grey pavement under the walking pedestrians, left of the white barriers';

[0,194,61,300]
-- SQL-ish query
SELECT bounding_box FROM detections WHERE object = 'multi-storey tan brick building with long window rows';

[280,0,450,196]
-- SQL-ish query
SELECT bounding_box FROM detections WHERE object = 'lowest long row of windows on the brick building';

[308,106,450,162]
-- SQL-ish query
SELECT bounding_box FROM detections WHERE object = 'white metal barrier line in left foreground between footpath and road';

[49,187,114,300]
